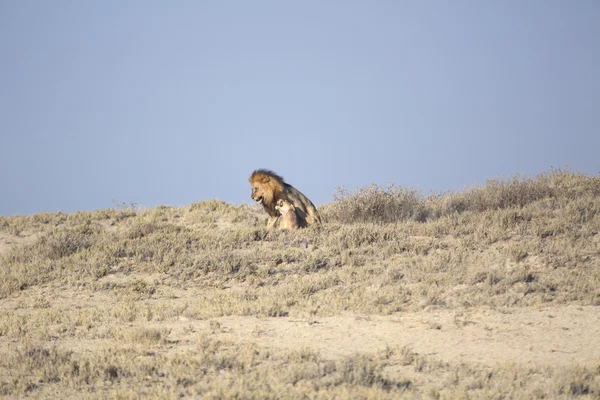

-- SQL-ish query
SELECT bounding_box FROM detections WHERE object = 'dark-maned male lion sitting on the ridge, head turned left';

[249,169,321,228]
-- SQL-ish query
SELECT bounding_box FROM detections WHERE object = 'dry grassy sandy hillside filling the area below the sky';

[0,170,600,399]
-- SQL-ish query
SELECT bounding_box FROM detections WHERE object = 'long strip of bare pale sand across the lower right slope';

[170,306,600,365]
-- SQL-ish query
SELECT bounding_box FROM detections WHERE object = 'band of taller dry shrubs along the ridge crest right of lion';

[323,169,600,224]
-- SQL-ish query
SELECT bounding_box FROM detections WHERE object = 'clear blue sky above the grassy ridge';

[0,0,600,215]
